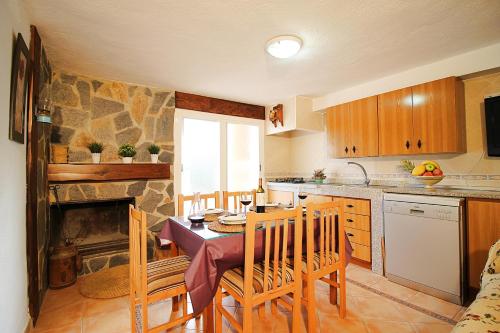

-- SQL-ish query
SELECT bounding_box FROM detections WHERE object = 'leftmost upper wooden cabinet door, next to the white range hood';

[326,104,350,158]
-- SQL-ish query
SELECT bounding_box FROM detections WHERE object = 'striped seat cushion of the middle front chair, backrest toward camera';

[222,262,293,296]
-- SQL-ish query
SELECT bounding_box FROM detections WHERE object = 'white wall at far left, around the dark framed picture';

[0,0,30,333]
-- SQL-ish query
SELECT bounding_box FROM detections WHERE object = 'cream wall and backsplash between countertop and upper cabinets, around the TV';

[284,73,500,187]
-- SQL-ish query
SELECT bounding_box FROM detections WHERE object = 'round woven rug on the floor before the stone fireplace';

[78,265,130,298]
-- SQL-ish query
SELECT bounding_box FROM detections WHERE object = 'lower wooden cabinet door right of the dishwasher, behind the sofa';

[467,199,500,289]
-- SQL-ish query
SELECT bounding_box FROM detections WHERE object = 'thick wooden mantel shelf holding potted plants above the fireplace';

[48,163,170,183]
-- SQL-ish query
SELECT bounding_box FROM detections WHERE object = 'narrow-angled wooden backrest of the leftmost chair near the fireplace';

[128,205,148,298]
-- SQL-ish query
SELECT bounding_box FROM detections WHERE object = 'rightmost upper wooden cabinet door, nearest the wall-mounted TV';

[412,77,465,153]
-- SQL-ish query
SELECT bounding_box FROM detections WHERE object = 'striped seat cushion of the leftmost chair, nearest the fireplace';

[148,256,191,294]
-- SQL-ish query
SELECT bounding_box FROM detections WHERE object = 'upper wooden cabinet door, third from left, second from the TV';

[378,88,417,156]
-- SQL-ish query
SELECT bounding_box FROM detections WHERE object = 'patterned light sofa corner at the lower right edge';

[452,239,500,333]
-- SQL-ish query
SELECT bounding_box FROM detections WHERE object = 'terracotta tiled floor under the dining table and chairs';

[32,265,463,333]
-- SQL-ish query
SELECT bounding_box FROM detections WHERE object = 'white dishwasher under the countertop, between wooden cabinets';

[384,193,465,304]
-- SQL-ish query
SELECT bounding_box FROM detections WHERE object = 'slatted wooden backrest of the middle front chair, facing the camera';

[243,207,303,299]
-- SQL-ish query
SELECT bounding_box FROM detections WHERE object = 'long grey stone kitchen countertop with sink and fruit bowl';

[268,182,500,200]
